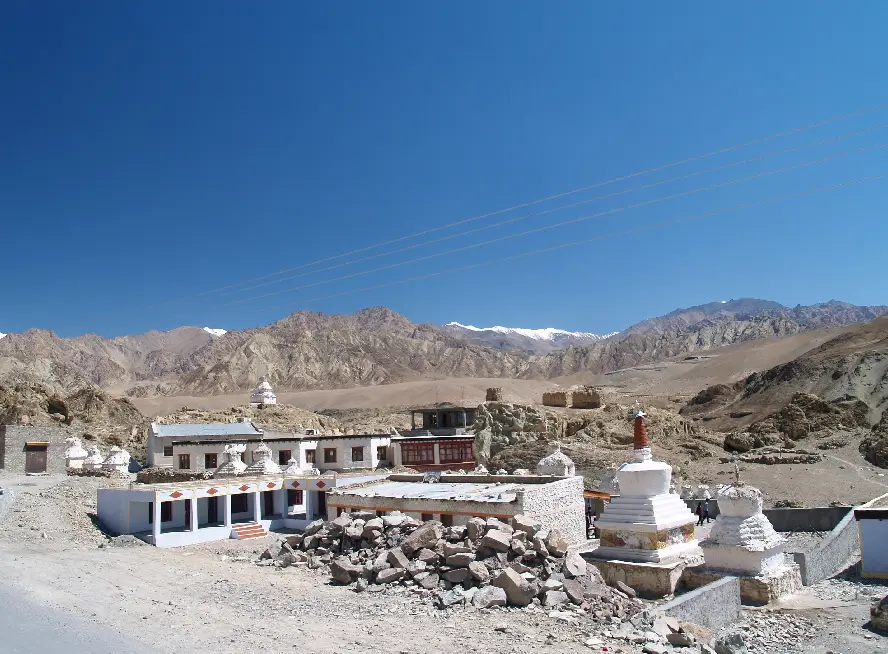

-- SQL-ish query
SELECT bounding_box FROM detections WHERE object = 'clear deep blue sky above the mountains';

[0,0,888,336]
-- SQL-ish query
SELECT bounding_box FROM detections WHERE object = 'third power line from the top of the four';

[224,143,888,305]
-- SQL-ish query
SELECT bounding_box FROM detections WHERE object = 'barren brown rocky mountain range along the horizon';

[0,299,888,397]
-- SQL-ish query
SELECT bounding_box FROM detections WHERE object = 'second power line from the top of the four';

[222,123,888,297]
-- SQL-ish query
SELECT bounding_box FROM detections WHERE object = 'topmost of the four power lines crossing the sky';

[189,103,888,299]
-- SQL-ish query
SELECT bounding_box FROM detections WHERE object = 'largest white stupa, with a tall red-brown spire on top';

[594,409,701,563]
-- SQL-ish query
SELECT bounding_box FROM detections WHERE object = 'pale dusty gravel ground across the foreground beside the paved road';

[0,477,888,654]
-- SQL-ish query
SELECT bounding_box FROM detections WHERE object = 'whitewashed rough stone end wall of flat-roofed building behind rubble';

[519,477,586,545]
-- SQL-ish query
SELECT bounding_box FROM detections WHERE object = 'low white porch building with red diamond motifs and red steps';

[97,474,385,547]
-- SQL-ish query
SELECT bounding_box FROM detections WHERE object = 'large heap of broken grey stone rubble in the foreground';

[260,512,665,624]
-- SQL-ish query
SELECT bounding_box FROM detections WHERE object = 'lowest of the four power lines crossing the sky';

[278,173,888,308]
